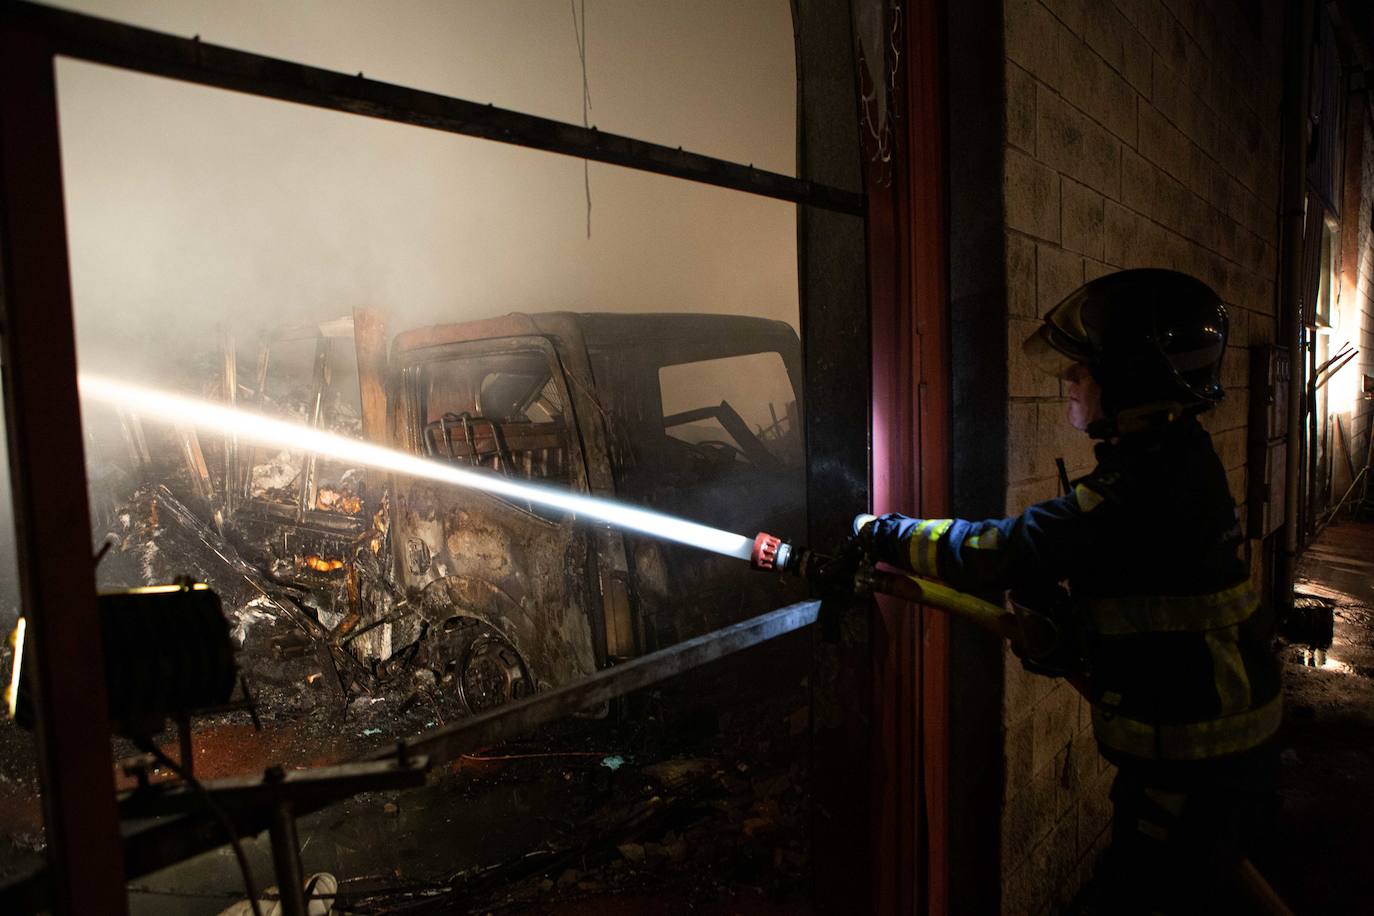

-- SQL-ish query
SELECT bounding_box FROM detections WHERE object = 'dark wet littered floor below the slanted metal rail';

[0,634,809,916]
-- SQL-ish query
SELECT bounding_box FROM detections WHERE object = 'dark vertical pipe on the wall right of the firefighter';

[1275,0,1314,604]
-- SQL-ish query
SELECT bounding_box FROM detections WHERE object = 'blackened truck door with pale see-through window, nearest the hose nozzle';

[577,313,807,651]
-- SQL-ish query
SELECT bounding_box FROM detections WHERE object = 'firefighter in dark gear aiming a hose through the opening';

[856,269,1281,913]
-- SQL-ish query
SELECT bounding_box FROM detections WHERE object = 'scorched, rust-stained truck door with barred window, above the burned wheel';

[389,336,602,711]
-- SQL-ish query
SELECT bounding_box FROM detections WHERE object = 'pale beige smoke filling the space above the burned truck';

[0,0,797,603]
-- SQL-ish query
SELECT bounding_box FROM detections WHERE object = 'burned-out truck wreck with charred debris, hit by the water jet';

[106,310,805,711]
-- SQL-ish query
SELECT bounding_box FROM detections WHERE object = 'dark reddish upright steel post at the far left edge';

[0,16,128,913]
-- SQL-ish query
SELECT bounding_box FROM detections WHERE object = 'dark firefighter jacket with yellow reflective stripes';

[874,416,1281,766]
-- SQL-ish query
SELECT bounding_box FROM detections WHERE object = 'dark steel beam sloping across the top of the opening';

[0,1,864,214]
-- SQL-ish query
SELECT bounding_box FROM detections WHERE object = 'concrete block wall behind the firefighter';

[1002,0,1280,913]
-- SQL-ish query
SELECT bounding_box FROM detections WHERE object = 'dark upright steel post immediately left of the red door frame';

[793,0,868,913]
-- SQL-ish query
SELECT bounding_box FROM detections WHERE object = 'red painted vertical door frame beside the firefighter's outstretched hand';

[864,0,951,915]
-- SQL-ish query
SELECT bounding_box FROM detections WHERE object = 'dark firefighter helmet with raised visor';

[1024,268,1228,416]
